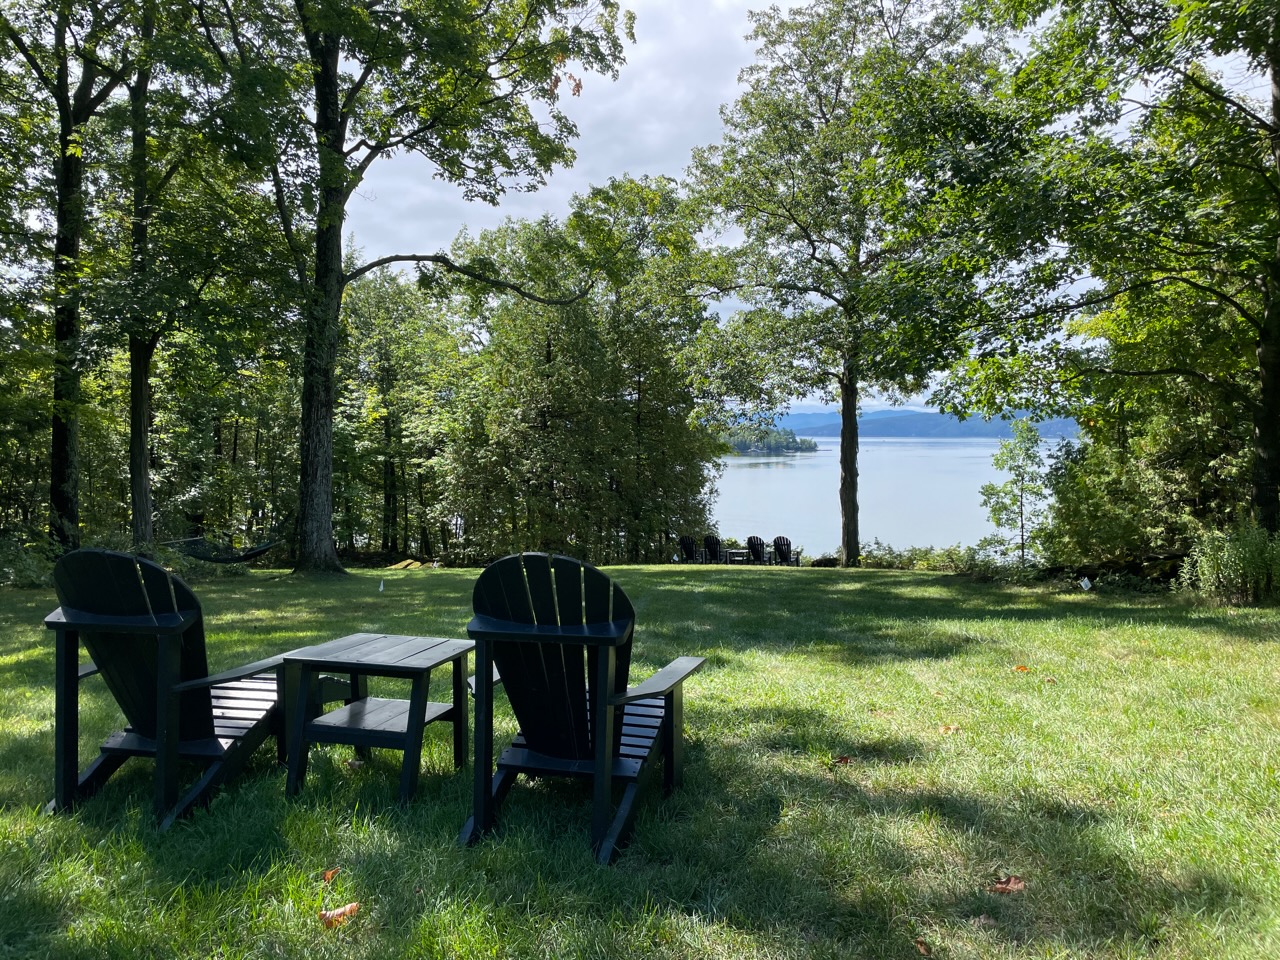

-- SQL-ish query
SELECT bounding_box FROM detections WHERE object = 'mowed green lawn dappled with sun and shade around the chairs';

[0,566,1280,960]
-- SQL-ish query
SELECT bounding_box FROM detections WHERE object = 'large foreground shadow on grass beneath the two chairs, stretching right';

[0,727,1249,960]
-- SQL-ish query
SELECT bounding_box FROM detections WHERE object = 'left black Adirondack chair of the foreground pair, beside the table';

[45,549,284,829]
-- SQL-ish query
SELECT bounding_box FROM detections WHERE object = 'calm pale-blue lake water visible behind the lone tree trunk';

[712,436,1009,557]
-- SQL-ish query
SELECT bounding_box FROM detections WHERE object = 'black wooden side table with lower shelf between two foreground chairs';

[282,634,475,803]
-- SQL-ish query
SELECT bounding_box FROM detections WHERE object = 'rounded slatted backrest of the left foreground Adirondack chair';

[54,549,214,740]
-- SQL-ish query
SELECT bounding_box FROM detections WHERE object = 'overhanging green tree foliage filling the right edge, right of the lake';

[950,0,1280,542]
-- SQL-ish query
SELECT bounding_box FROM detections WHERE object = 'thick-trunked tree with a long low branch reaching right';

[227,0,630,571]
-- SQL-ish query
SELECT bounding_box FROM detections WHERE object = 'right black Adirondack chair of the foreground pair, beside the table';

[460,553,703,864]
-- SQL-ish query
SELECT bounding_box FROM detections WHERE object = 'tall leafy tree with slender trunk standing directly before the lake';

[690,0,1007,561]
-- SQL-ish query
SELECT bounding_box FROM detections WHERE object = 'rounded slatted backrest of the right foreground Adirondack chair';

[471,553,635,760]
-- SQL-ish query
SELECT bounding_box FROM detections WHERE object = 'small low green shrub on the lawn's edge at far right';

[1180,520,1280,604]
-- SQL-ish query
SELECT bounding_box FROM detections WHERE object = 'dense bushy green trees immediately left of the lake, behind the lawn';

[424,180,722,562]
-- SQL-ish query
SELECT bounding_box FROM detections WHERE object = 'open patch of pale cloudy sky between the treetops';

[347,0,767,260]
